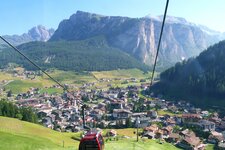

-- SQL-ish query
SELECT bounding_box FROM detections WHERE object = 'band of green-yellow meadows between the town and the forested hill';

[0,69,151,94]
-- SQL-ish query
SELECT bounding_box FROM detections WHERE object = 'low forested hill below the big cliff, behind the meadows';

[0,37,148,71]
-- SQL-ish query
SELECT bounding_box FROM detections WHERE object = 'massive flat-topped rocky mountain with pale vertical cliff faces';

[50,11,223,67]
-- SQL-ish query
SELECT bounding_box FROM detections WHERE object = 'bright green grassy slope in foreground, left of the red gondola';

[0,117,79,149]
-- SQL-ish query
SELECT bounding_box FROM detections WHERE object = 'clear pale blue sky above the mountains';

[0,0,225,35]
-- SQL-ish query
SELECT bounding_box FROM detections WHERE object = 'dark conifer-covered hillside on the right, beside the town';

[148,41,225,108]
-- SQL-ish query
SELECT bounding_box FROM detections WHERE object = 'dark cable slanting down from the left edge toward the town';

[0,36,70,93]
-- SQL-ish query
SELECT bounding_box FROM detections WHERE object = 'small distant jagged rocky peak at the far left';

[0,25,54,47]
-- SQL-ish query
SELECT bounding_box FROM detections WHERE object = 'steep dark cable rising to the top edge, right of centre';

[150,0,169,87]
